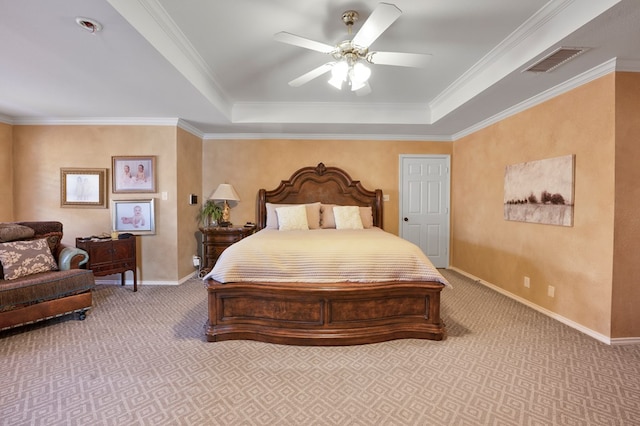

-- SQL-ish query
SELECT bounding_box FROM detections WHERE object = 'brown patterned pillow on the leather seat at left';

[0,239,58,280]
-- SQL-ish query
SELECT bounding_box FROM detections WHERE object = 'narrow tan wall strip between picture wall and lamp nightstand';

[176,128,202,279]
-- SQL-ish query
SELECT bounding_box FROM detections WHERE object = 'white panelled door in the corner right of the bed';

[399,155,451,268]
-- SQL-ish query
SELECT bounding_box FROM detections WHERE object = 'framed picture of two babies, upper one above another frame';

[111,155,158,194]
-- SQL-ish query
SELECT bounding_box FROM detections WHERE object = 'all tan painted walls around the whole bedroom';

[7,73,640,337]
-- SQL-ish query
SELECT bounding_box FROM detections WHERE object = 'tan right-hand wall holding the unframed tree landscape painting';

[452,74,616,336]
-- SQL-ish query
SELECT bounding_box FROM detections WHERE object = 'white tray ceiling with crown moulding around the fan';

[0,0,640,140]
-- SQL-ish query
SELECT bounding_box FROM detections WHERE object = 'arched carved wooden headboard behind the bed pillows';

[257,163,382,229]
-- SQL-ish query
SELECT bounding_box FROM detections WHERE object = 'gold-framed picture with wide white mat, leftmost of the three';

[60,168,107,209]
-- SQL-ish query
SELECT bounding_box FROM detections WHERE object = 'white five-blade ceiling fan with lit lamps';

[274,3,431,95]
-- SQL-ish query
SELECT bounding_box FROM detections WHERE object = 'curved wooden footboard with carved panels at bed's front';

[206,280,446,346]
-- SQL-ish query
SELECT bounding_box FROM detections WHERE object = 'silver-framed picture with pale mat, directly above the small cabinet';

[111,198,156,235]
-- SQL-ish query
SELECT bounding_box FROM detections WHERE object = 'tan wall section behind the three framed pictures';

[13,126,178,283]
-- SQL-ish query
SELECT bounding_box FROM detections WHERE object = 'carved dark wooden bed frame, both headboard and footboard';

[206,163,445,346]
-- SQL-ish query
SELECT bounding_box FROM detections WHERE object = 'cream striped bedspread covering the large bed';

[204,228,448,285]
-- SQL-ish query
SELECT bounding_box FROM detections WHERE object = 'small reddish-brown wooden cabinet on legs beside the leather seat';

[76,236,138,291]
